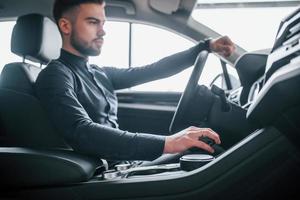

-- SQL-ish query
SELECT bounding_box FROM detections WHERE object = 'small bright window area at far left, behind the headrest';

[0,21,18,72]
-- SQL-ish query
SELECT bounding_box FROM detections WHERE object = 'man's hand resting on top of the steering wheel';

[209,36,235,57]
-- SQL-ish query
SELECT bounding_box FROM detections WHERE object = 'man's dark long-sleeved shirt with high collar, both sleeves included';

[35,42,205,160]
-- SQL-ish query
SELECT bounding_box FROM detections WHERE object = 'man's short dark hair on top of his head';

[53,0,104,23]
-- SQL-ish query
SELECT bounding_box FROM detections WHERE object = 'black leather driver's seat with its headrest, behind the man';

[0,14,70,149]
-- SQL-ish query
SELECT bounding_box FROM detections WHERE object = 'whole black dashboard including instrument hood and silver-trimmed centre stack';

[228,9,300,145]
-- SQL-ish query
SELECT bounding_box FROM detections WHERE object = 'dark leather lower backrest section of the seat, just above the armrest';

[0,89,70,149]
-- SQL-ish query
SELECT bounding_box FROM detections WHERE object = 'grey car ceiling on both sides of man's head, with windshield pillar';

[0,0,245,63]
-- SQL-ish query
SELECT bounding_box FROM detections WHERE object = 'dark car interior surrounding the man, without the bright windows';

[0,0,300,200]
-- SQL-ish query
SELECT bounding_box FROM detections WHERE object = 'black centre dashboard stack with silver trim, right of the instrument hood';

[247,9,300,146]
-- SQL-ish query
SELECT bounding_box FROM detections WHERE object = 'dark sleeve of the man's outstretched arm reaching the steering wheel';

[103,42,206,90]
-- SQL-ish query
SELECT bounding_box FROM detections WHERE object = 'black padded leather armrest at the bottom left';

[0,147,102,187]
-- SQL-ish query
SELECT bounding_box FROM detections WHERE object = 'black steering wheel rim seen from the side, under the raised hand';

[169,51,208,133]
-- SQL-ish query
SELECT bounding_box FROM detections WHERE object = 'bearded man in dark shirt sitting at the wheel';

[36,0,234,160]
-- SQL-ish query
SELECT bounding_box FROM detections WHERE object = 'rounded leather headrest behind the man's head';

[11,14,62,64]
